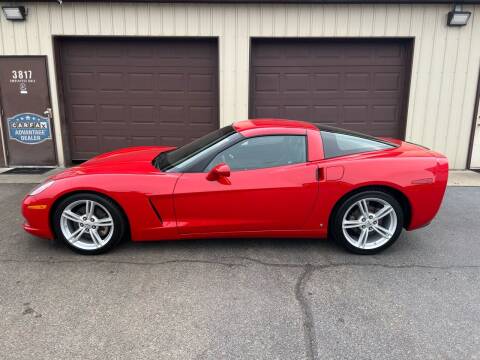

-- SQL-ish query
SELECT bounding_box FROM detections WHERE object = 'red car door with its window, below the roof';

[174,135,318,234]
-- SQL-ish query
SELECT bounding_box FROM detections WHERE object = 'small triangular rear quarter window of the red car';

[321,131,394,159]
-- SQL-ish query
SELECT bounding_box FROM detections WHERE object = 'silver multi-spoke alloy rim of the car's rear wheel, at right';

[342,198,397,250]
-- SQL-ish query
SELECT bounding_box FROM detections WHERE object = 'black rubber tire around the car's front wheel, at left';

[52,193,127,255]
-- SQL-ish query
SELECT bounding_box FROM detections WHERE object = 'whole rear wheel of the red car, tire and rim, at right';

[332,191,403,254]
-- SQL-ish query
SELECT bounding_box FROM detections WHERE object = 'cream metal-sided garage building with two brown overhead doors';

[0,0,480,169]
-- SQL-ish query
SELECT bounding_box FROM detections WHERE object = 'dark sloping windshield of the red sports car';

[153,126,235,171]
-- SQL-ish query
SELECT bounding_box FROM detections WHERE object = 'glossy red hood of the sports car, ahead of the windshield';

[52,146,175,180]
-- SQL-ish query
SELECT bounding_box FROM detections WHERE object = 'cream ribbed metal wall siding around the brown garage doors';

[0,2,480,169]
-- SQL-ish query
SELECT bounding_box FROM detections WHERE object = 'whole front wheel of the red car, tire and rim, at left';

[53,193,125,255]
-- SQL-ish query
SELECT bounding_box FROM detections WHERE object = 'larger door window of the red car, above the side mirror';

[205,135,307,171]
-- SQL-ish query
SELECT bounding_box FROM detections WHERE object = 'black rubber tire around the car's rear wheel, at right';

[330,190,404,255]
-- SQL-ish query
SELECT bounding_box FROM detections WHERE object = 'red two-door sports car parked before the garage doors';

[22,119,448,254]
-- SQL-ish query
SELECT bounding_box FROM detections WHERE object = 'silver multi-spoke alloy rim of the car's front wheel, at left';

[60,200,114,250]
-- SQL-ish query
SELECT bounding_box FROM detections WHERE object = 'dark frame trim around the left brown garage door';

[52,35,221,166]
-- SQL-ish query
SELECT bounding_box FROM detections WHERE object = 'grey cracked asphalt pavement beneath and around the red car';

[0,184,480,360]
